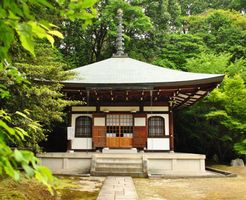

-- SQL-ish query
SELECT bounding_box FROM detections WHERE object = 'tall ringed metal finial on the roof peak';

[113,9,127,57]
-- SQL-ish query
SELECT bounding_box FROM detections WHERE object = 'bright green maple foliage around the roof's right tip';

[177,52,246,161]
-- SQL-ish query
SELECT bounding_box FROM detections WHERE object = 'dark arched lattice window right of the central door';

[148,116,165,137]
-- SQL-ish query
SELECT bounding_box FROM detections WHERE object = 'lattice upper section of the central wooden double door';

[106,114,133,137]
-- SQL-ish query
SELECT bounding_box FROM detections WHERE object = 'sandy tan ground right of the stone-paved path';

[134,165,246,200]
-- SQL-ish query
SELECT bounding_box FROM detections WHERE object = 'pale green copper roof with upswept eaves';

[63,57,224,85]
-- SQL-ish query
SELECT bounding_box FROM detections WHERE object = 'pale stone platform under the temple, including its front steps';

[37,152,209,177]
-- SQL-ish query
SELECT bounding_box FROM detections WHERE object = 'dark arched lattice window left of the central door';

[75,116,92,137]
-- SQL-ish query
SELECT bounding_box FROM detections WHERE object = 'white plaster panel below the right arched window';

[147,138,170,150]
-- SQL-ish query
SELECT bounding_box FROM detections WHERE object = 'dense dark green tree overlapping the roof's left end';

[2,41,76,152]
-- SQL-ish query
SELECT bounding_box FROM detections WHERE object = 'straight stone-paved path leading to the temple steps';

[97,176,138,200]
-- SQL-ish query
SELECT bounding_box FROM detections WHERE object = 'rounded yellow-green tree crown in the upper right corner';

[184,10,246,61]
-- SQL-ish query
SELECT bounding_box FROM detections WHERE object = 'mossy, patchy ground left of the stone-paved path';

[0,177,103,200]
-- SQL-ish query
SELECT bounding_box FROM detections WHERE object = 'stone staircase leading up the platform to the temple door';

[91,154,147,177]
